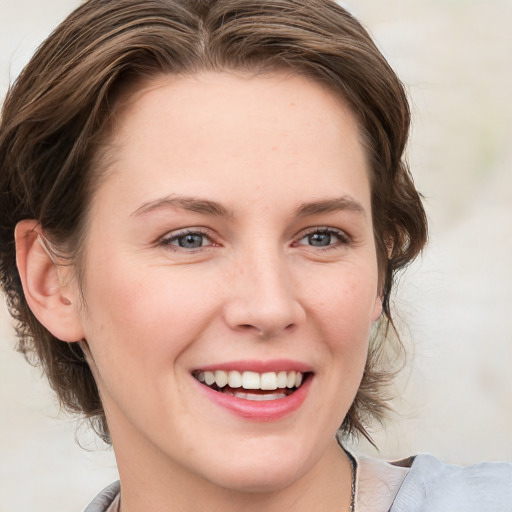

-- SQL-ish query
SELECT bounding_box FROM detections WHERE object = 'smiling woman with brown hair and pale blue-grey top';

[0,0,512,512]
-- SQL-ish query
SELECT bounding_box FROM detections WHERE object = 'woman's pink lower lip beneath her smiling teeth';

[196,375,313,421]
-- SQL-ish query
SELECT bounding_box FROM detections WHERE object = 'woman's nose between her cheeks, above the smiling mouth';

[224,251,306,339]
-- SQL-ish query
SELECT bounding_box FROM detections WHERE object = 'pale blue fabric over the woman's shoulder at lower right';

[391,455,512,512]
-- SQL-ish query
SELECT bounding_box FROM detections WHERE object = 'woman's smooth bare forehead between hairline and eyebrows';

[94,72,367,216]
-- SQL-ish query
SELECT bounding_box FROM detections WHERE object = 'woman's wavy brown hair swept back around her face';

[0,0,427,440]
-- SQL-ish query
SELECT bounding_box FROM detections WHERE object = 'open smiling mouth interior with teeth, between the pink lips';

[192,370,309,402]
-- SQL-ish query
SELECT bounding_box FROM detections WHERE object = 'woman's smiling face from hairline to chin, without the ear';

[75,73,381,490]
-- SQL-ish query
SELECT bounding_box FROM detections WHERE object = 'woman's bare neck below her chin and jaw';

[114,439,352,512]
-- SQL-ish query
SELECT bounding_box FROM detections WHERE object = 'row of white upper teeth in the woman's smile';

[196,370,303,390]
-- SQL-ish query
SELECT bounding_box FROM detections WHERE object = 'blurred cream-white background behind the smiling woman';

[0,0,512,512]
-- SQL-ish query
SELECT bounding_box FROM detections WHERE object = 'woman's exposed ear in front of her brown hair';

[14,220,84,342]
